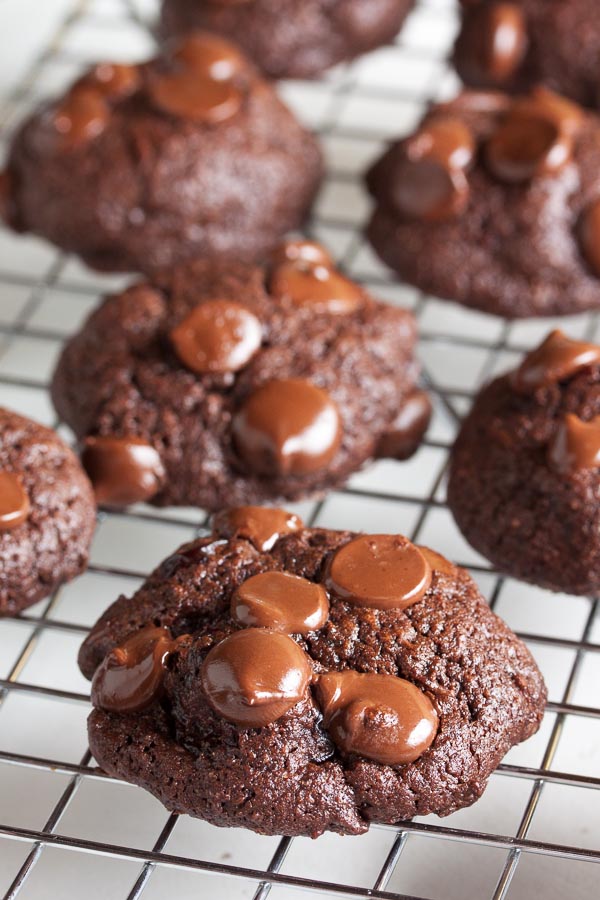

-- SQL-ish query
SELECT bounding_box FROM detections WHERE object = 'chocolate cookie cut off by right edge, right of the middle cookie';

[448,331,600,594]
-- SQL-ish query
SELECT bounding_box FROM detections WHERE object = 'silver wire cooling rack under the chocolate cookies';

[0,0,600,900]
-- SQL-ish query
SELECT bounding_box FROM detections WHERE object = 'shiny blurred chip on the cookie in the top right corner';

[458,3,528,85]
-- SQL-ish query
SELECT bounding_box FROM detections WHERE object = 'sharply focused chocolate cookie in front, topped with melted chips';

[79,508,546,837]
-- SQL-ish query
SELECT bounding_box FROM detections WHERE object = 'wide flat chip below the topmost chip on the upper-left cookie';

[148,70,242,125]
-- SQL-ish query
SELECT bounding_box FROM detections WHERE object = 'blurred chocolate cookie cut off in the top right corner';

[454,0,600,107]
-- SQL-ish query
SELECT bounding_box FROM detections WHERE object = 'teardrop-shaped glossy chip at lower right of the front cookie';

[316,671,438,766]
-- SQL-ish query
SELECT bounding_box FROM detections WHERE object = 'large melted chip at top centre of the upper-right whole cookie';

[486,88,582,183]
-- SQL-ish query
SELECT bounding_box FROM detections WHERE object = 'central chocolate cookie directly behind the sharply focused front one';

[52,241,430,510]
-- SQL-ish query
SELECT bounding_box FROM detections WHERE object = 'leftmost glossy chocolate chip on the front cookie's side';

[92,627,175,713]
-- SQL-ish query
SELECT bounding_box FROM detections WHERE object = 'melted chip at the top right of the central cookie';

[269,259,364,315]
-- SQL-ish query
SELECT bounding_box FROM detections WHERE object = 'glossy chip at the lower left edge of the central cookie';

[81,436,165,507]
